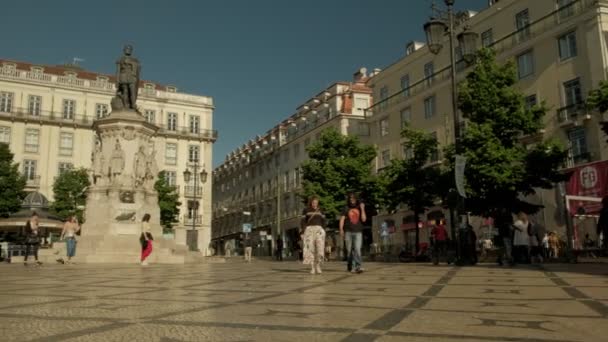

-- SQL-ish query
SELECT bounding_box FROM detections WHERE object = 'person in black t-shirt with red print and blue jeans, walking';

[340,193,367,273]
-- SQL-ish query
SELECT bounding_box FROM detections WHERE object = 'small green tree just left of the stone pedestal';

[51,168,91,223]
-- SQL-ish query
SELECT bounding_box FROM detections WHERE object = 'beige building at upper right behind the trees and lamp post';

[367,0,608,246]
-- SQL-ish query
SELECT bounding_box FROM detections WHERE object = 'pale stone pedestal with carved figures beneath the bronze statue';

[78,110,184,263]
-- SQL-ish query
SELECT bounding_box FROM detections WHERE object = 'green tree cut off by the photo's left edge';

[0,143,26,217]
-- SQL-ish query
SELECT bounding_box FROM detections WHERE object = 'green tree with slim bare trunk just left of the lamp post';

[380,126,441,254]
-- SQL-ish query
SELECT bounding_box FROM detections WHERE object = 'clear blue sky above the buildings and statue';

[0,0,487,166]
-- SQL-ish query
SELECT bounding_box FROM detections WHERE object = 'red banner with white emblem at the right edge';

[566,160,608,215]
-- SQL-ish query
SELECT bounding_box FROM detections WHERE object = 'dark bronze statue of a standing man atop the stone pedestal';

[111,45,141,111]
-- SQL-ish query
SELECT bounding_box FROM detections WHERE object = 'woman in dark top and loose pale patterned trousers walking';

[302,196,325,274]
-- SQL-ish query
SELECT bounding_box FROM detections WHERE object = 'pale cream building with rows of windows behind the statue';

[0,60,217,252]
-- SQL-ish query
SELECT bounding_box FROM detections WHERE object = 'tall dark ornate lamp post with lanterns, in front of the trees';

[424,0,477,260]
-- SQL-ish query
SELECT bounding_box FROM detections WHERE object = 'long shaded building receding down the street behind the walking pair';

[212,68,372,255]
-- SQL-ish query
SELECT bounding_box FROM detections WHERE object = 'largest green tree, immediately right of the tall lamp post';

[456,49,567,216]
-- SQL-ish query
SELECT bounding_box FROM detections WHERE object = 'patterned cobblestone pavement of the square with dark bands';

[0,261,608,342]
